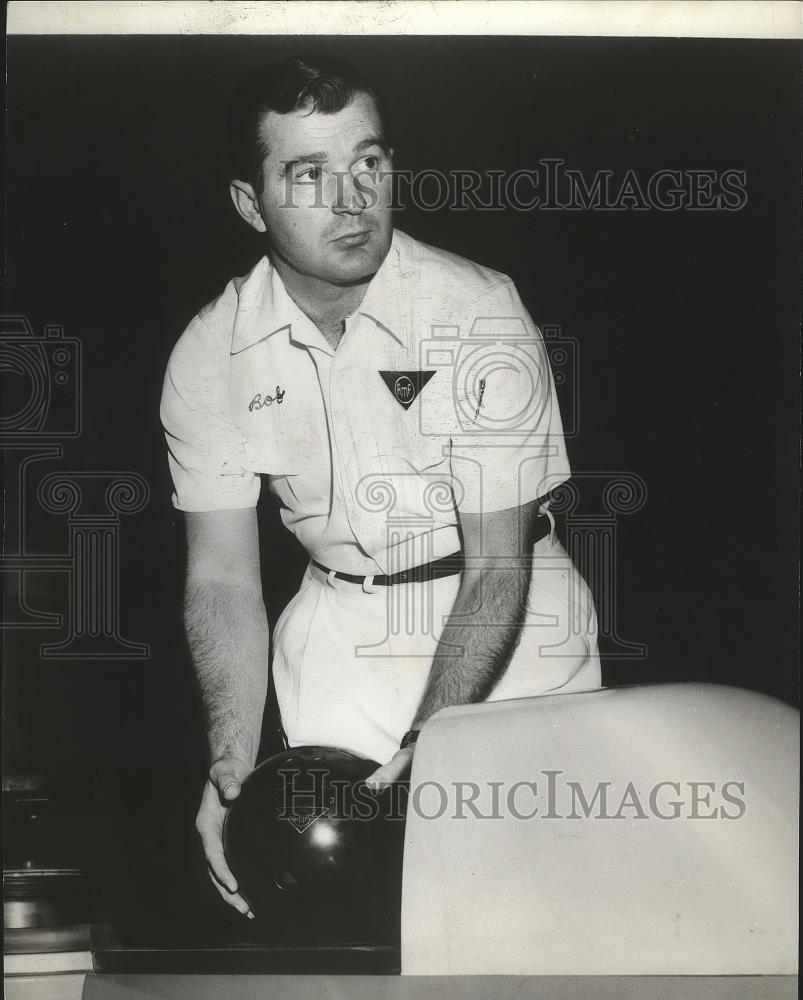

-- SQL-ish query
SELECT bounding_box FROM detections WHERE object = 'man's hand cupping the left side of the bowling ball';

[195,757,254,919]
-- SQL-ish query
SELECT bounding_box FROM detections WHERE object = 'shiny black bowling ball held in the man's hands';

[223,746,404,943]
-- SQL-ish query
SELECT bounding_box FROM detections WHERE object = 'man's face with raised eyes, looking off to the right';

[253,94,393,285]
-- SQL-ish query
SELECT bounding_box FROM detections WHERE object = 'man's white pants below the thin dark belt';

[273,532,601,763]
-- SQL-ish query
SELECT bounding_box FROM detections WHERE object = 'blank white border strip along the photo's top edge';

[7,0,803,39]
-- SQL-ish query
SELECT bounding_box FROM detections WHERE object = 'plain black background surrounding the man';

[5,37,801,928]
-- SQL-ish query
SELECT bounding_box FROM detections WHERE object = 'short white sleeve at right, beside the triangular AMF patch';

[450,279,571,513]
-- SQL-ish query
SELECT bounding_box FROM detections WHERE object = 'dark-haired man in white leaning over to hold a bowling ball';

[162,52,600,915]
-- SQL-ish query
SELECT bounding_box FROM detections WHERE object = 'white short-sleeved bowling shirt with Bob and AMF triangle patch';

[161,230,570,575]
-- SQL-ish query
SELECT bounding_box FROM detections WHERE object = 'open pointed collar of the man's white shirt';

[231,230,410,354]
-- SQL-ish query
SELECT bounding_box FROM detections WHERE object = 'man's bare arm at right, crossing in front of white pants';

[412,501,538,729]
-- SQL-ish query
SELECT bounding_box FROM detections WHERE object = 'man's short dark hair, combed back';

[228,56,387,190]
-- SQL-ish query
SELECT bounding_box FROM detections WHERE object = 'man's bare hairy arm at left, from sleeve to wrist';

[184,509,269,766]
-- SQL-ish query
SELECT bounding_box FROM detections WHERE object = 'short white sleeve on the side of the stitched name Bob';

[160,317,260,511]
